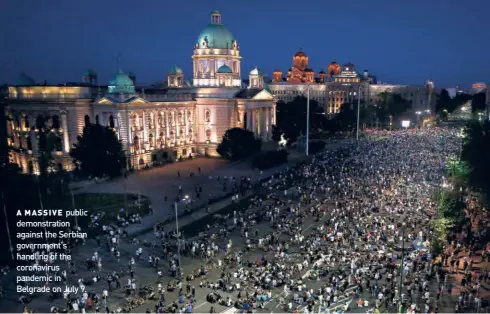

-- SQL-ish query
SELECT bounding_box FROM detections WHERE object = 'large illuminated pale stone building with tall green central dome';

[5,11,276,173]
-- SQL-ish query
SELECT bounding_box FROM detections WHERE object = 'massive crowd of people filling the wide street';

[1,128,489,313]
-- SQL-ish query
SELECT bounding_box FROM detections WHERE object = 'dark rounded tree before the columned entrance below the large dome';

[217,128,262,160]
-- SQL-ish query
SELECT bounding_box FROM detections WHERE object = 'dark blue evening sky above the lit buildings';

[0,0,490,87]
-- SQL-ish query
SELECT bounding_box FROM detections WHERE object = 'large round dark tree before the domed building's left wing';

[70,124,126,178]
